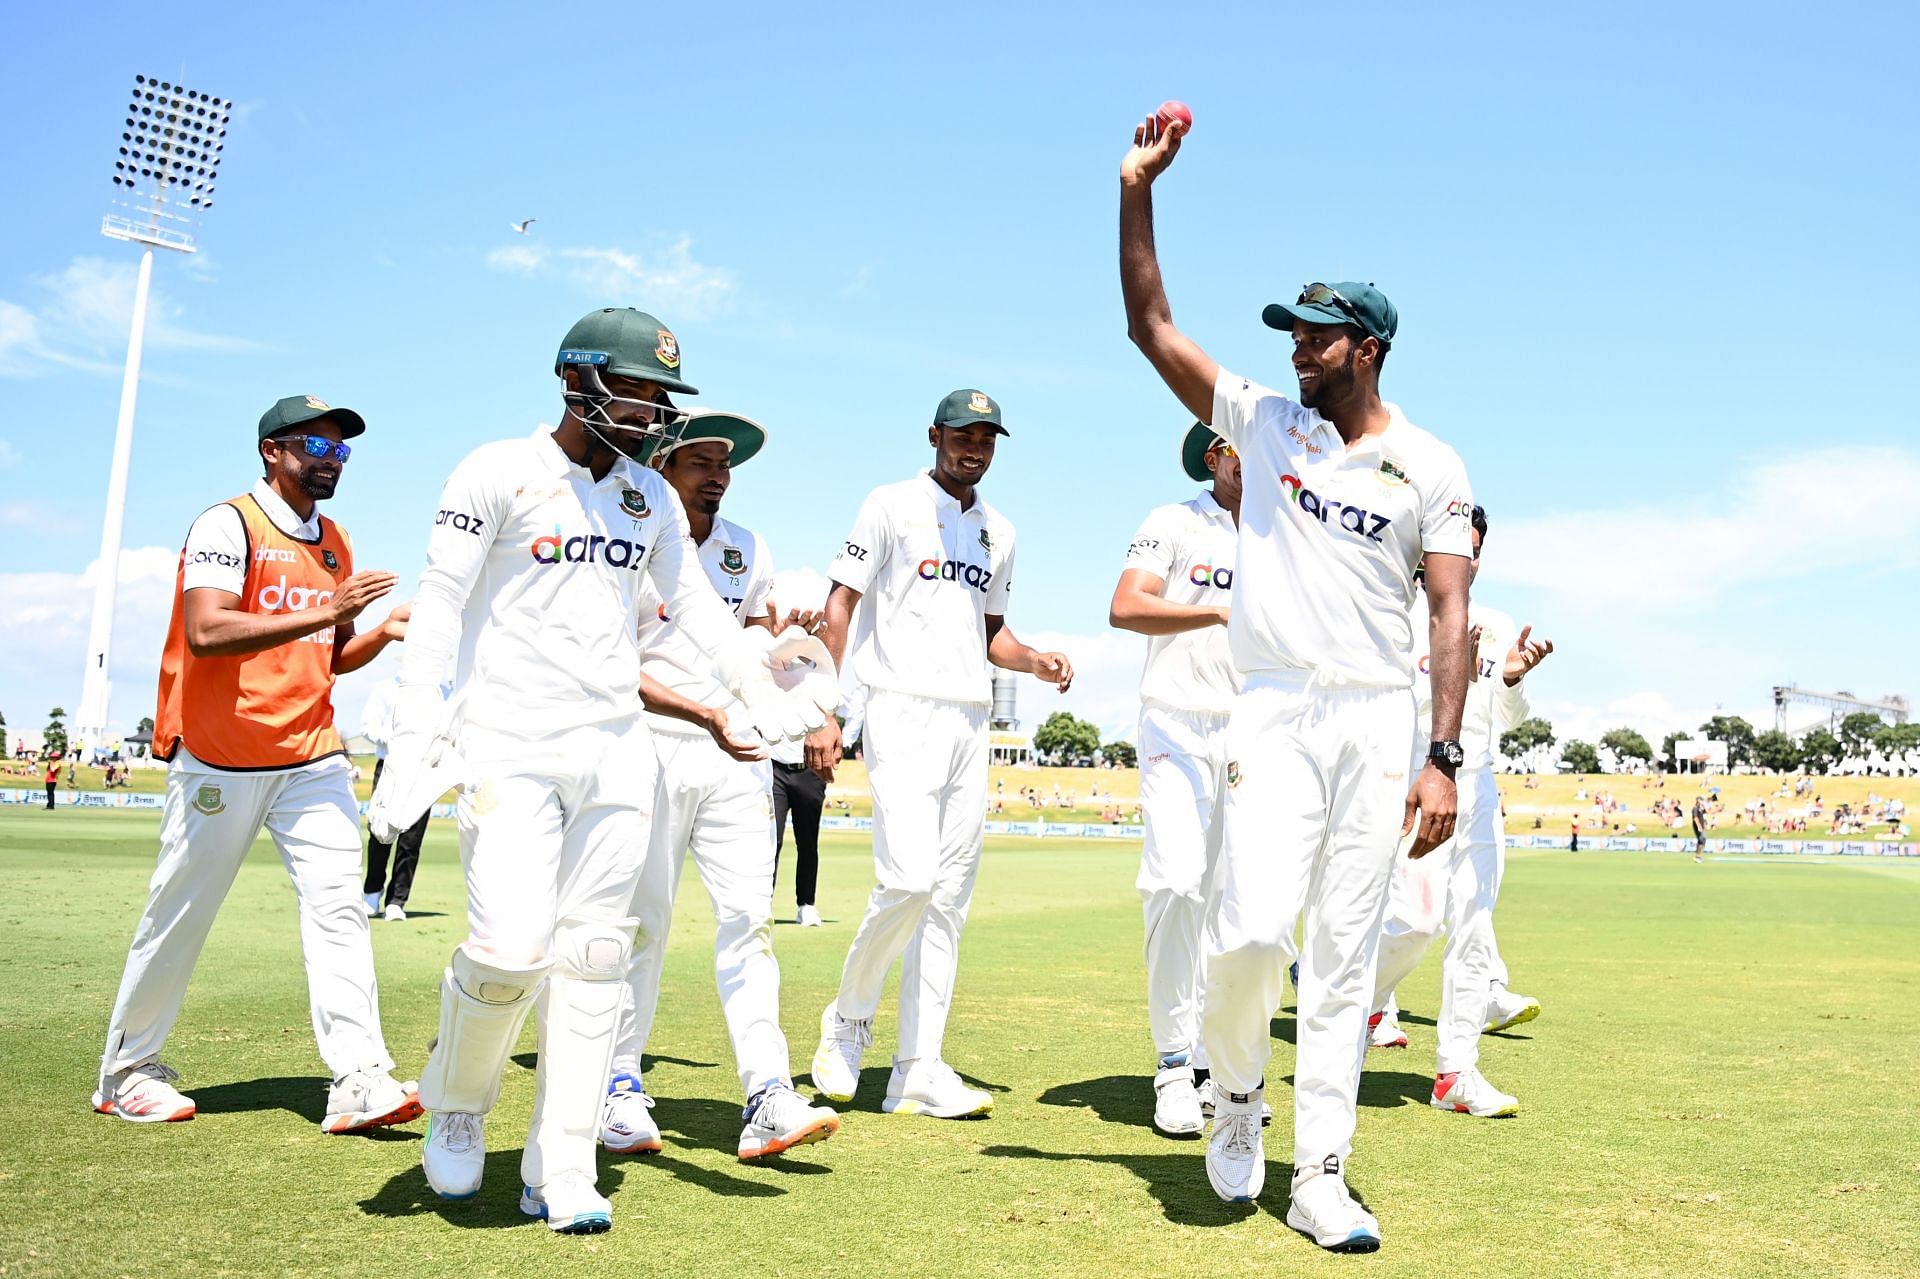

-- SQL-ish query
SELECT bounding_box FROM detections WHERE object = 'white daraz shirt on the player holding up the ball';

[1213,369,1473,688]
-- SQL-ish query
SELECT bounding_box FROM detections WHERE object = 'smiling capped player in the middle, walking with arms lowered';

[806,390,1073,1120]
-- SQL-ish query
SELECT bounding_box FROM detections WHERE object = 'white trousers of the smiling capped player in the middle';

[837,689,987,1062]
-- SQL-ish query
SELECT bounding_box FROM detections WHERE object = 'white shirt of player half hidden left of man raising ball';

[1125,490,1240,714]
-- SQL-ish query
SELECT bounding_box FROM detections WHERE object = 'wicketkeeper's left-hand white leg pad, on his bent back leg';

[420,945,549,1114]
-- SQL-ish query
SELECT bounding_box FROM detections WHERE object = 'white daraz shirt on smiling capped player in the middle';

[828,471,1014,707]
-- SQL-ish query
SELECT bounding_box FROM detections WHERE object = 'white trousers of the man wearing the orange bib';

[100,745,394,1083]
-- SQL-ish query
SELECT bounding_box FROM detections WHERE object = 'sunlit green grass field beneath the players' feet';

[0,808,1920,1279]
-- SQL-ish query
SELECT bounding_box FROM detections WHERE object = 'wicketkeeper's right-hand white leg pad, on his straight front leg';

[520,918,639,1185]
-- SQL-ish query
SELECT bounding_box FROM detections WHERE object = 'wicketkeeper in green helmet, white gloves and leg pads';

[369,307,820,1235]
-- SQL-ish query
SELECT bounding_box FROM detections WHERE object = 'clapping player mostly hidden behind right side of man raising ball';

[1369,507,1553,1118]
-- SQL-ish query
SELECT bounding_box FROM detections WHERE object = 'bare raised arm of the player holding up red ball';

[1119,115,1219,424]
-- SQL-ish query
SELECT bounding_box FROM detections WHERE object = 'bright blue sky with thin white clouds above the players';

[0,4,1920,748]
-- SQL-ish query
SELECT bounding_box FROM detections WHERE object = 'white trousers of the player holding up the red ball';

[1200,670,1413,1168]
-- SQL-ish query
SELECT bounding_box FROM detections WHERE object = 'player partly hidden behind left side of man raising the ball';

[1108,422,1240,1137]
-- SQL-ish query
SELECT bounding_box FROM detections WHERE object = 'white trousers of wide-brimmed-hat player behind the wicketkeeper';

[612,730,793,1097]
